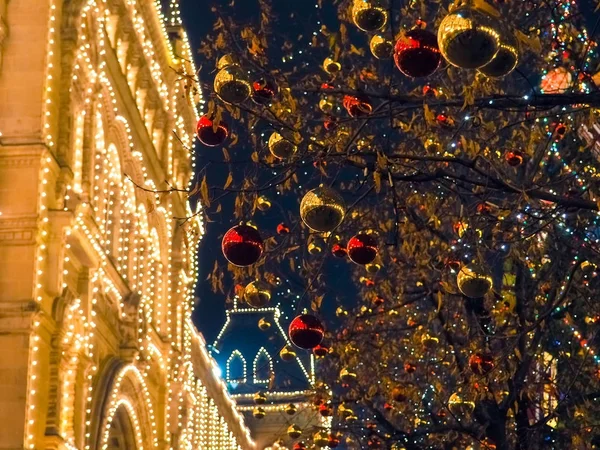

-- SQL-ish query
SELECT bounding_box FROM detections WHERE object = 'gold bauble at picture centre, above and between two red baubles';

[300,186,346,233]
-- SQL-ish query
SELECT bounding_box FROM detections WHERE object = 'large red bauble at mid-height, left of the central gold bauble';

[221,224,264,267]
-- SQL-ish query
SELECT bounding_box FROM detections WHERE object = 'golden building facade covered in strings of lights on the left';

[0,0,255,450]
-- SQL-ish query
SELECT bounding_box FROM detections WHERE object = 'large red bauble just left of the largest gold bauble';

[394,28,442,78]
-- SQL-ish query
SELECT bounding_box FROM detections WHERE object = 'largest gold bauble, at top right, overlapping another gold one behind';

[438,5,500,69]
